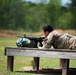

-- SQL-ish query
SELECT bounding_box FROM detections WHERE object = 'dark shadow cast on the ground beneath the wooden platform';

[15,68,76,75]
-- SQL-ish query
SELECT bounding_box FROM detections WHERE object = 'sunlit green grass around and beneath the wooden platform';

[0,37,76,75]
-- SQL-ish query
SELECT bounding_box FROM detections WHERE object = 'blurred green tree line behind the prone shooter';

[0,0,76,31]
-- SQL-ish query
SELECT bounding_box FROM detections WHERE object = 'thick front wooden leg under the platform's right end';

[62,59,69,75]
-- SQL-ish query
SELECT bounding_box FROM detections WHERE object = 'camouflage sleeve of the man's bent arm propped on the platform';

[38,33,54,49]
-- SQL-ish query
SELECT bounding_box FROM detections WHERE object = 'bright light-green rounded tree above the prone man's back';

[57,12,73,29]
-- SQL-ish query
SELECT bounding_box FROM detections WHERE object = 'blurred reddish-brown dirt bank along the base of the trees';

[0,29,76,37]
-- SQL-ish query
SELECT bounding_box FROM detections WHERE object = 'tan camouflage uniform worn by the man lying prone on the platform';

[39,31,76,49]
